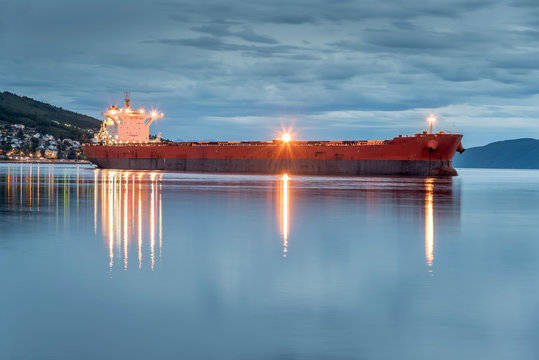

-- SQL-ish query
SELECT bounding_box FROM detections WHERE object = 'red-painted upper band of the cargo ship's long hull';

[83,133,462,175]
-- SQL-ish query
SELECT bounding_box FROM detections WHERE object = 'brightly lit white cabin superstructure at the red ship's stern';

[97,94,163,143]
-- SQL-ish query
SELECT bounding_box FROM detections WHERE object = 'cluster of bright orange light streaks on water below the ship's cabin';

[94,169,163,271]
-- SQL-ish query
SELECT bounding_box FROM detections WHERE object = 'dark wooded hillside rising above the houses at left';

[0,92,101,140]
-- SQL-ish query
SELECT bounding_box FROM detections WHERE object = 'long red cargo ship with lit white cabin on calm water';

[83,94,464,176]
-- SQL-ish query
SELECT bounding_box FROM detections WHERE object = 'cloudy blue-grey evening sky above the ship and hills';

[0,0,539,147]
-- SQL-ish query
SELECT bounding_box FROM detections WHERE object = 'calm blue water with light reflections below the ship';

[0,164,539,359]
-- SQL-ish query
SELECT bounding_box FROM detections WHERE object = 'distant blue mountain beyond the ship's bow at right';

[453,139,539,169]
